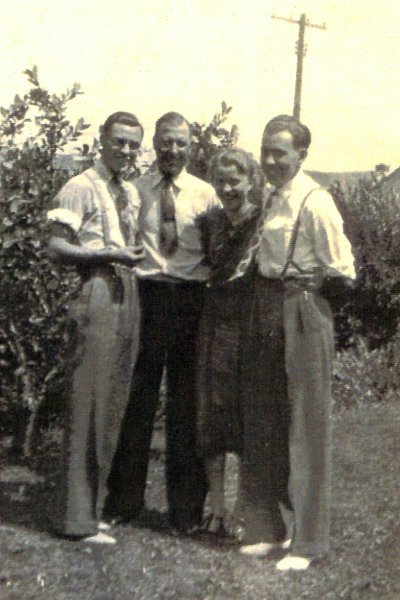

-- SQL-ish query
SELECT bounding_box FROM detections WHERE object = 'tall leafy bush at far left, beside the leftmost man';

[0,67,88,452]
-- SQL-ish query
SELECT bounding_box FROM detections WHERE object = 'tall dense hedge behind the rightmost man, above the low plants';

[332,182,400,348]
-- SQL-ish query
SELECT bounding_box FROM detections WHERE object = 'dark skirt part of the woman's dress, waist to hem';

[197,278,252,457]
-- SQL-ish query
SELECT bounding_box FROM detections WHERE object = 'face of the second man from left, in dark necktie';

[153,123,191,177]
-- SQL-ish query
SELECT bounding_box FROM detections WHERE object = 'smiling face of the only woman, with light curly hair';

[213,165,251,214]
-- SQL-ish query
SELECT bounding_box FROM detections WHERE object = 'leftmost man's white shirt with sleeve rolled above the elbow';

[48,160,140,249]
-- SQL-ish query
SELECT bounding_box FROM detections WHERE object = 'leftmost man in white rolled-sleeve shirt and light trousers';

[48,111,143,544]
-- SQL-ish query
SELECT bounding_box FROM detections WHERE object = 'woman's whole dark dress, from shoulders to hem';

[197,205,259,457]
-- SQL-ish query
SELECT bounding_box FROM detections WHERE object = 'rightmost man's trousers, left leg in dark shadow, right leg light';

[241,276,333,557]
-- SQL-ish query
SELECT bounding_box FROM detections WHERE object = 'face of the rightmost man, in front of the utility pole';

[261,131,307,187]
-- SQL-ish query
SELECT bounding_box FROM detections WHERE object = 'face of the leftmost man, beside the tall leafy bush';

[100,123,143,173]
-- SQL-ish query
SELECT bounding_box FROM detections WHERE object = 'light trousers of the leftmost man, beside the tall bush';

[56,267,139,535]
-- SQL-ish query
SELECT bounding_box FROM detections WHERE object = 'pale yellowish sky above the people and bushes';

[0,0,400,171]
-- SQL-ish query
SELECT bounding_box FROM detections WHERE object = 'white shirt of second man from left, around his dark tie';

[135,169,221,281]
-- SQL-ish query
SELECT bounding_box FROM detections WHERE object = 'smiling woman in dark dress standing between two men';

[197,148,262,532]
